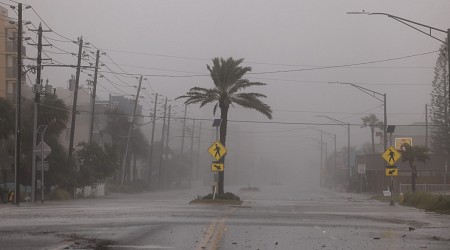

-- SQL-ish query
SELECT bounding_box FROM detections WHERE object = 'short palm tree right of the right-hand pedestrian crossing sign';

[400,143,429,192]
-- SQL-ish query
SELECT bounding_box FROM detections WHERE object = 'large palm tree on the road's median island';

[177,57,272,194]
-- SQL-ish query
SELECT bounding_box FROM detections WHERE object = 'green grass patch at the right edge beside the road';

[401,192,450,214]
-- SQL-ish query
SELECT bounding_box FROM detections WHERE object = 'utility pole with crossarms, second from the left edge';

[30,23,50,202]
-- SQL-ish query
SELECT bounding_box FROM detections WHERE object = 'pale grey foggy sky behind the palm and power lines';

[19,0,450,189]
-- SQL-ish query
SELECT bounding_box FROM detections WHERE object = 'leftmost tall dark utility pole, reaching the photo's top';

[14,3,23,205]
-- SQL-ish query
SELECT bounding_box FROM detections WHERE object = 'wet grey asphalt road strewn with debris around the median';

[0,183,450,250]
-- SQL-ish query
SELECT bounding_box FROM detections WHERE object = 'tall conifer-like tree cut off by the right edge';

[430,37,450,154]
